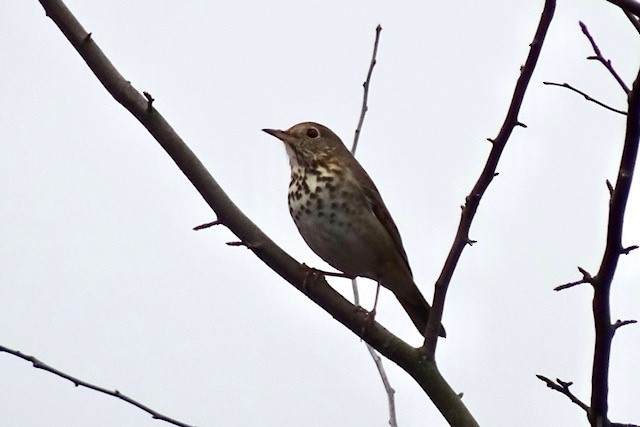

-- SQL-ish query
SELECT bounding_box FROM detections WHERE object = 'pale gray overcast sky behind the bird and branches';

[0,0,640,426]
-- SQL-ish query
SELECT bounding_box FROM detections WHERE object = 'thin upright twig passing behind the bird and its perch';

[351,25,398,427]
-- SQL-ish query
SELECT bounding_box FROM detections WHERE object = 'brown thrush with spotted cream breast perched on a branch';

[263,122,445,337]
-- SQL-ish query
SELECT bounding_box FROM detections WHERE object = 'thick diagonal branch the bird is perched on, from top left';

[35,0,477,426]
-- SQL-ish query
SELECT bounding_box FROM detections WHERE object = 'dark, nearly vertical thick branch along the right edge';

[590,61,640,427]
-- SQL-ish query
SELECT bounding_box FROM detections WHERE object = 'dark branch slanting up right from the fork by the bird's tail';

[423,0,556,360]
